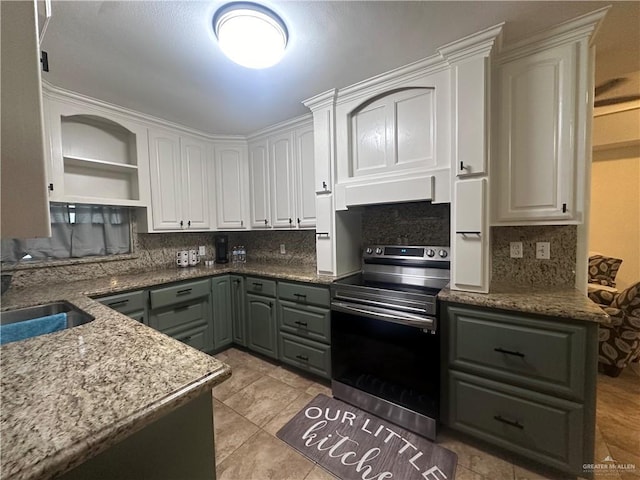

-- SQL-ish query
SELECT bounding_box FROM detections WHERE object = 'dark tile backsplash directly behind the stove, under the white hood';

[362,202,451,246]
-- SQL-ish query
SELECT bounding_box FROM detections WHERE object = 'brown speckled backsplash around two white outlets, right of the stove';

[491,225,577,287]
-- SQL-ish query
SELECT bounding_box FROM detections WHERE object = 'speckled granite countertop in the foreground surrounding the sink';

[0,281,240,479]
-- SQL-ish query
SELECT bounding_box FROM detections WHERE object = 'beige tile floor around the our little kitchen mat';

[213,348,640,480]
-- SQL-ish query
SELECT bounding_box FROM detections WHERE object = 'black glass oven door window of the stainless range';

[331,310,440,418]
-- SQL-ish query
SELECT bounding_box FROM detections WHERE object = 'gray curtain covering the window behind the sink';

[2,204,131,262]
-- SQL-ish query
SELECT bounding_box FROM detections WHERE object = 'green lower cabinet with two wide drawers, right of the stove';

[440,303,598,477]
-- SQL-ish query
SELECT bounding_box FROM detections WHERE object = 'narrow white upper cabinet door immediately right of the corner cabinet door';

[249,139,271,228]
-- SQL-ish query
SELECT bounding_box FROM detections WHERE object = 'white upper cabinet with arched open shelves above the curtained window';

[44,89,150,207]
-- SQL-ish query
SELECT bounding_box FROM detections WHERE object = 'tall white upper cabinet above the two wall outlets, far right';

[491,10,606,225]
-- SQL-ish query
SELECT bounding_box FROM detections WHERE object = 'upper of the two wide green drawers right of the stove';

[446,306,587,399]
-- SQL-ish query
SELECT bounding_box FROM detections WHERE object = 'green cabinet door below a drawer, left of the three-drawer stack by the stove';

[245,293,278,359]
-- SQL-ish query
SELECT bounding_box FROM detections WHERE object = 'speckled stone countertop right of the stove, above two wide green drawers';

[438,284,610,324]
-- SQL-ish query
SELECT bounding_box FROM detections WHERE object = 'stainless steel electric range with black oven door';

[331,245,450,439]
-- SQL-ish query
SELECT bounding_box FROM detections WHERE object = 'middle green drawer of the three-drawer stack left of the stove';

[278,300,331,343]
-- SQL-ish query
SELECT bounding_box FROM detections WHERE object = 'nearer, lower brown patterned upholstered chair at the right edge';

[589,282,640,377]
